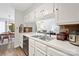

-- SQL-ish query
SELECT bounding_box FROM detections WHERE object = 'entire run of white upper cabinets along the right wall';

[24,3,79,25]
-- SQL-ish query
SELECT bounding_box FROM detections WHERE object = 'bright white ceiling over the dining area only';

[0,3,15,20]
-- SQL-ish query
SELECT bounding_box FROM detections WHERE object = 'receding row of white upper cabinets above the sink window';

[24,3,54,21]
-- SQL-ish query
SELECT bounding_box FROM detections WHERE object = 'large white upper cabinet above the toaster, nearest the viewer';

[56,3,79,25]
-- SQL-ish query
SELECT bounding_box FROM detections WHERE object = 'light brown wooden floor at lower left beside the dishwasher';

[0,45,26,56]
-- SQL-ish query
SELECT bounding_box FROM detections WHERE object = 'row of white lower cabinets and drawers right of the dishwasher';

[29,40,69,56]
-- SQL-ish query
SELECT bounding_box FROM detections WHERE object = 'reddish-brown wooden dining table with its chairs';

[0,32,14,45]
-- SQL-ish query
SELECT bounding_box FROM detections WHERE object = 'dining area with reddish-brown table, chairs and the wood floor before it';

[0,32,25,56]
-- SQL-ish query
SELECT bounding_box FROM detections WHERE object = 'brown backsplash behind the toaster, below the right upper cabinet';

[60,24,79,32]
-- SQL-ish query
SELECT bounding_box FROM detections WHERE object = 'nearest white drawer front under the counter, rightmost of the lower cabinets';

[47,47,68,56]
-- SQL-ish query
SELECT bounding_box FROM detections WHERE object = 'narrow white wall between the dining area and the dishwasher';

[14,10,23,47]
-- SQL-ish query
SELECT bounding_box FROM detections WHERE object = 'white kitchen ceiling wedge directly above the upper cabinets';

[10,3,42,11]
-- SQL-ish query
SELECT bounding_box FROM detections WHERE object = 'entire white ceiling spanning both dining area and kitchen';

[0,3,41,19]
